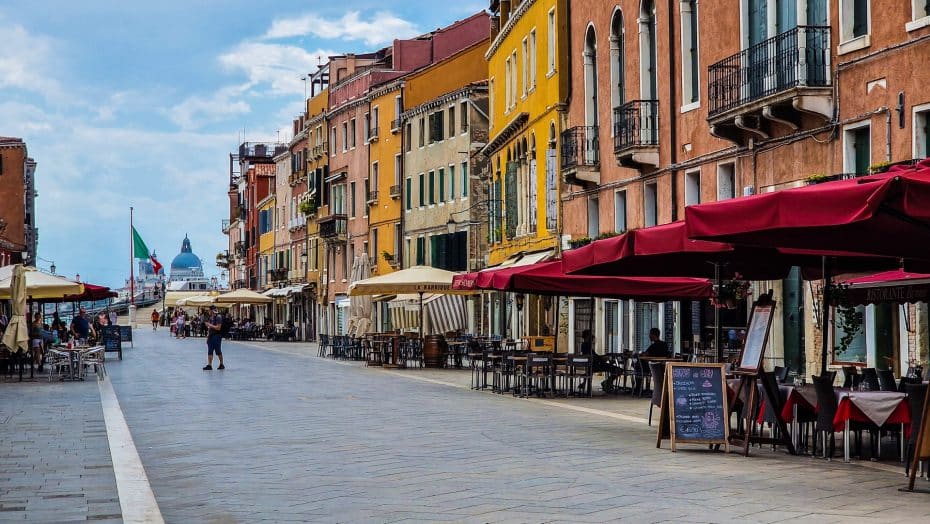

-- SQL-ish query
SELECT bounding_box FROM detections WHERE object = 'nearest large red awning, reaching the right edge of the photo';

[685,160,930,260]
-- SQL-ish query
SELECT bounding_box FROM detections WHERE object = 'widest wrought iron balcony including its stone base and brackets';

[707,26,833,141]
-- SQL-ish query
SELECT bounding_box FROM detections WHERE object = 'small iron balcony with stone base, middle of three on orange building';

[614,100,659,165]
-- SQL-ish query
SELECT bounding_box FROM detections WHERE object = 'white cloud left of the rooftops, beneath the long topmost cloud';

[219,42,336,95]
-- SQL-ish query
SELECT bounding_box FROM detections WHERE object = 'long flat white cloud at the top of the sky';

[265,11,419,45]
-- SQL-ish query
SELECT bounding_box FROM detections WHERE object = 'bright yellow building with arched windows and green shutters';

[484,0,571,266]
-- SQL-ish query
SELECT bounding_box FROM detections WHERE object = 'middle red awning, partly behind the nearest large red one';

[562,221,884,280]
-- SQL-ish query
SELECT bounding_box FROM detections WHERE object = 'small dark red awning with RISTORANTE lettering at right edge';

[843,269,930,304]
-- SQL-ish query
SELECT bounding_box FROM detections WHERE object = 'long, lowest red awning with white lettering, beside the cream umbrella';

[453,260,713,301]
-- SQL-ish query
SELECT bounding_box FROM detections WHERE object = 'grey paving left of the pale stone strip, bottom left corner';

[0,375,121,522]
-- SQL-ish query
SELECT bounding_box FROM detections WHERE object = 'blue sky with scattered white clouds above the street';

[0,0,487,287]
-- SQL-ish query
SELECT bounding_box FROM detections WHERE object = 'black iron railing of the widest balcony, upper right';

[707,26,831,117]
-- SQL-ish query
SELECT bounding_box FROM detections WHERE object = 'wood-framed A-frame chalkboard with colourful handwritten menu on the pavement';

[656,362,730,451]
